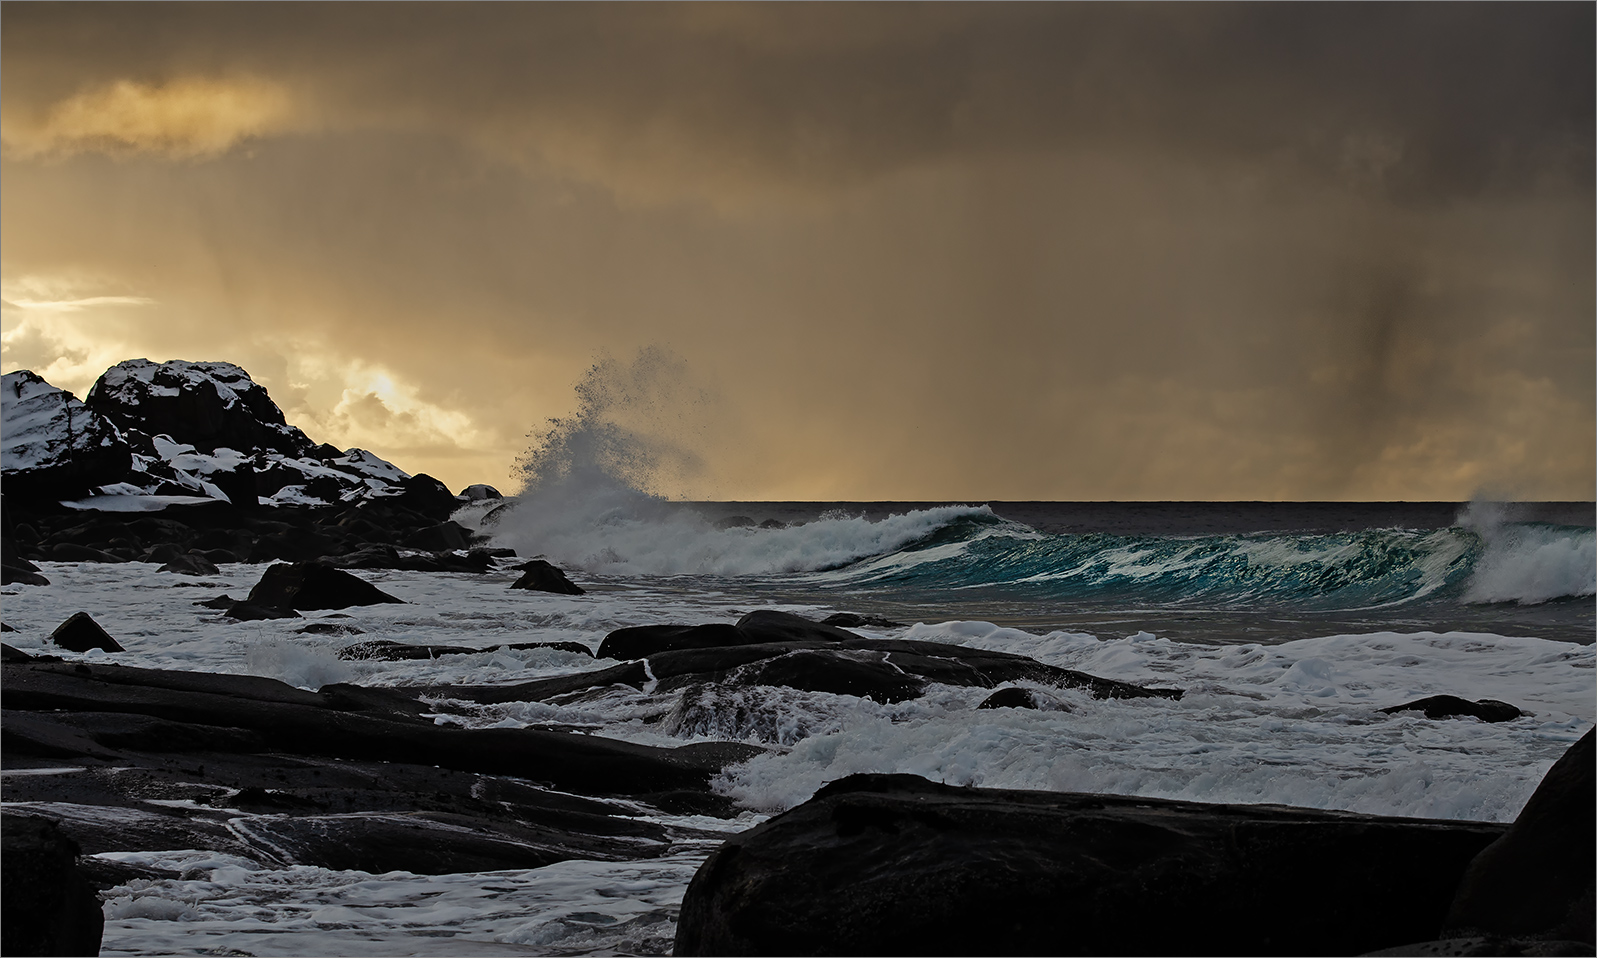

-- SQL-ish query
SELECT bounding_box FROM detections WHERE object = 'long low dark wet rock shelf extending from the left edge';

[0,650,760,874]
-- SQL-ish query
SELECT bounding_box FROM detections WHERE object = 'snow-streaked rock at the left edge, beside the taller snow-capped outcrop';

[0,369,133,498]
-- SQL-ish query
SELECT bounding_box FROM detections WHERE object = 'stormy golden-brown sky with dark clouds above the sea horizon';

[0,3,1597,500]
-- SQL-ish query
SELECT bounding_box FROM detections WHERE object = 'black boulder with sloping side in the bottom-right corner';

[1447,731,1597,955]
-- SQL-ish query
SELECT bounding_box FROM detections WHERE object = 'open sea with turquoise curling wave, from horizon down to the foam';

[679,501,1597,643]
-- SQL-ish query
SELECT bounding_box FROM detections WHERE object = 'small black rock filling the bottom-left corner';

[0,811,105,955]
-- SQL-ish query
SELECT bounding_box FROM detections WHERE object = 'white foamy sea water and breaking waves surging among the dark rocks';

[3,497,1597,955]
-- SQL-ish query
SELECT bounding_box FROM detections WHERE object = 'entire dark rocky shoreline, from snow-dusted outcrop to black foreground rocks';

[0,361,1597,955]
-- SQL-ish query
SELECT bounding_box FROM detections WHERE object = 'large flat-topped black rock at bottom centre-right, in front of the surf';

[676,774,1506,955]
